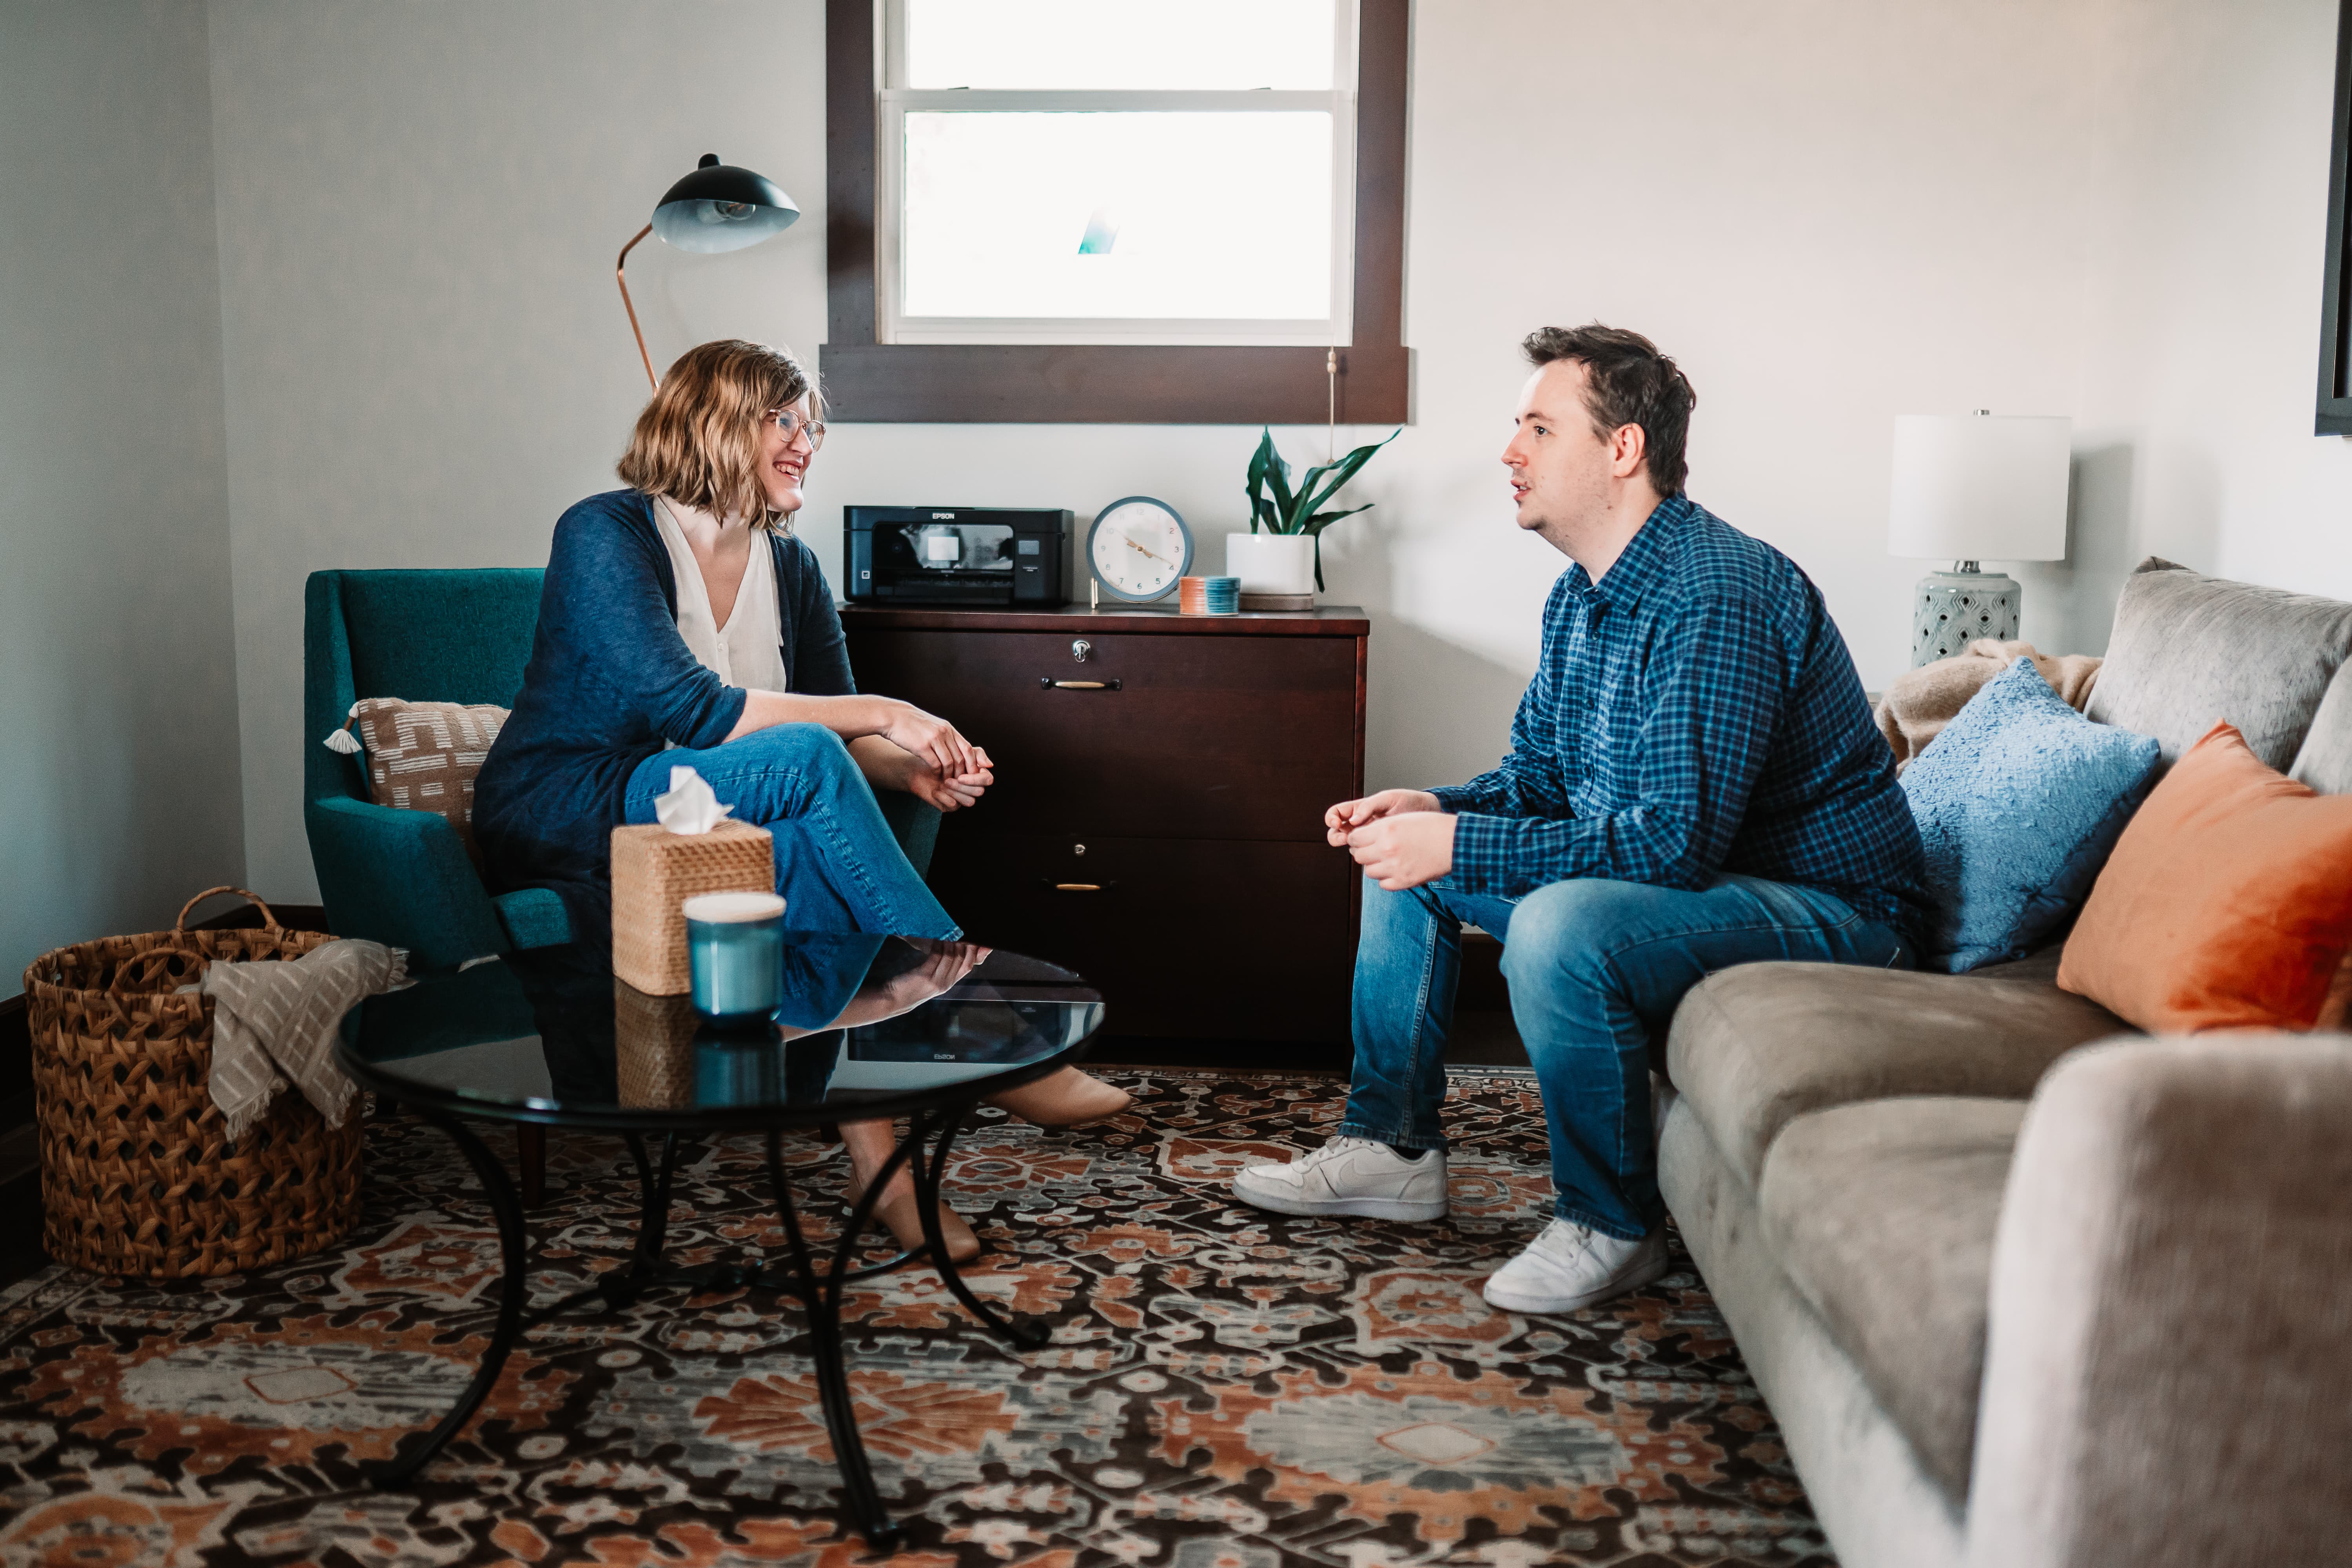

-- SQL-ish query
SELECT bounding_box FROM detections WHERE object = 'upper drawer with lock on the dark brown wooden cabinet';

[849,628,1359,844]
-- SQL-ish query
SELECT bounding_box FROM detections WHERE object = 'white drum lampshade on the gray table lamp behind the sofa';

[1886,414,2072,562]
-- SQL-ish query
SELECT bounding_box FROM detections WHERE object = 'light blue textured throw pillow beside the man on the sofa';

[1903,658,2157,976]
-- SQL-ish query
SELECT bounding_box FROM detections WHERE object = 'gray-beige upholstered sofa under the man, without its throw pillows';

[1658,559,2352,1568]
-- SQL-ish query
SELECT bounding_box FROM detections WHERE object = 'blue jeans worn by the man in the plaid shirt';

[1338,877,1912,1241]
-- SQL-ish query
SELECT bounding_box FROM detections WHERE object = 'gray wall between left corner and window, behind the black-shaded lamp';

[212,0,826,898]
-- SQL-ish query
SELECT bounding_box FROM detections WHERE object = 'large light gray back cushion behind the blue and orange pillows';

[2084,557,2352,771]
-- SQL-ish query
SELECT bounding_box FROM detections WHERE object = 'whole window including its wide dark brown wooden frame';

[823,0,1404,423]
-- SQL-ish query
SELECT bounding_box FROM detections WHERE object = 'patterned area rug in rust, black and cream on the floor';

[0,1072,1830,1568]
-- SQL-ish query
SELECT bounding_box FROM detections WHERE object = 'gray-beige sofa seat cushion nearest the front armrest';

[1757,1098,2025,1507]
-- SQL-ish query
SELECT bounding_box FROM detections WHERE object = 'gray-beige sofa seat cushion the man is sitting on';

[1665,955,2129,1192]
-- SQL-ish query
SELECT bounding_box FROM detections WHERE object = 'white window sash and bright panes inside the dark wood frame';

[875,0,1355,348]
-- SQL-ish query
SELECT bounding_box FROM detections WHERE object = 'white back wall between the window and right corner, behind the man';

[1350,0,2084,783]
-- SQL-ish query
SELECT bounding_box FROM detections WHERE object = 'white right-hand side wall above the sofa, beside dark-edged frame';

[2072,0,2352,651]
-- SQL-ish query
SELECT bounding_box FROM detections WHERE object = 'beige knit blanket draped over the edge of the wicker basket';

[202,940,409,1140]
